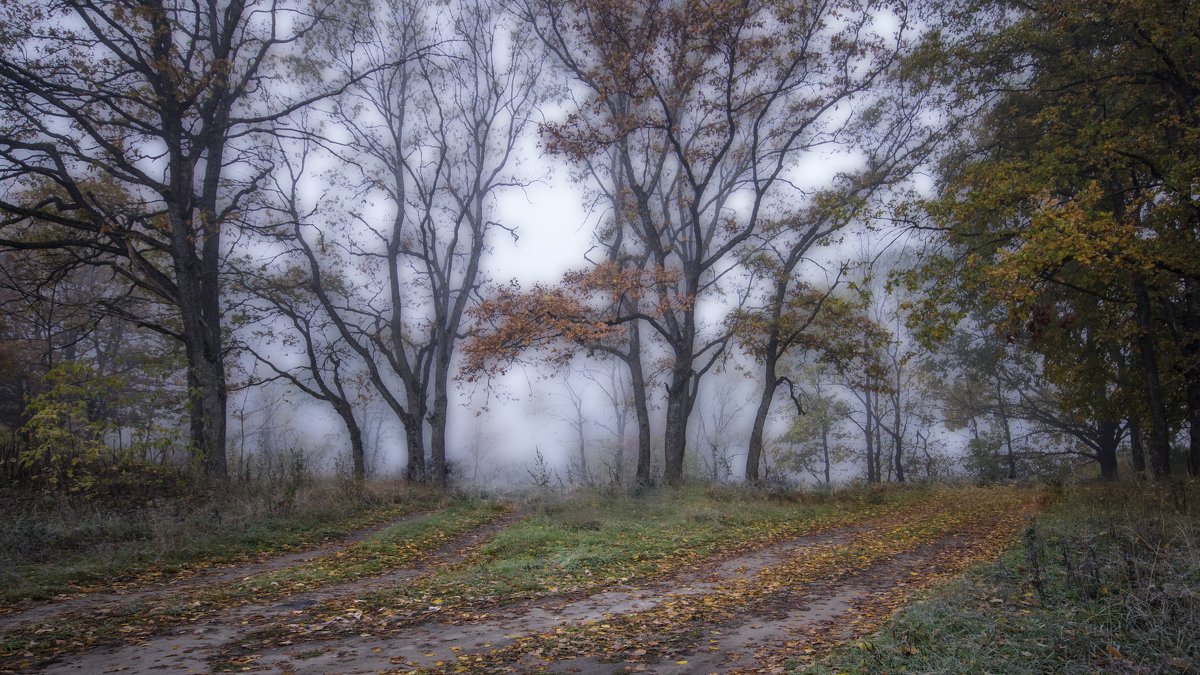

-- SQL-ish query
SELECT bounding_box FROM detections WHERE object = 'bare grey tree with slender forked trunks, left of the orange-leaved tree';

[270,0,541,485]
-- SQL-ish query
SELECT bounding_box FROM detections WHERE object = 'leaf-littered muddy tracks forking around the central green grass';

[4,494,1028,674]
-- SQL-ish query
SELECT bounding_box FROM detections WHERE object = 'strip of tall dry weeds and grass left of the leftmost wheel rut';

[0,480,446,600]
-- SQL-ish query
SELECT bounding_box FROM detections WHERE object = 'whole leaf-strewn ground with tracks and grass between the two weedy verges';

[0,488,1042,674]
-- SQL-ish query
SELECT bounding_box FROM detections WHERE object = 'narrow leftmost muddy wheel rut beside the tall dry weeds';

[0,510,431,632]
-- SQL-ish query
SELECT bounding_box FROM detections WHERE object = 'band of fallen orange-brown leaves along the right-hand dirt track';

[408,489,1036,673]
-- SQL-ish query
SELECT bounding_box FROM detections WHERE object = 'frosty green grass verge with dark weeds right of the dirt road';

[794,483,1200,673]
